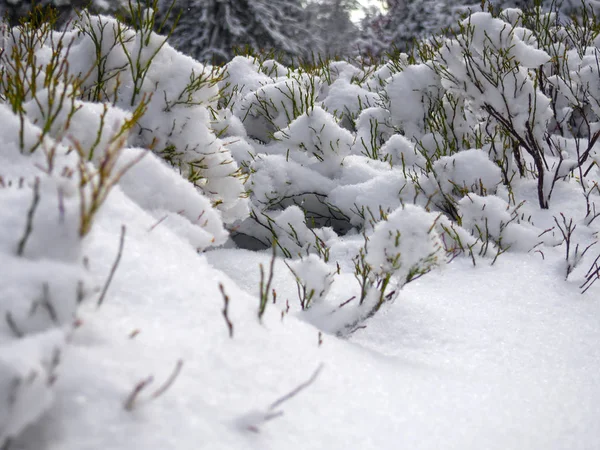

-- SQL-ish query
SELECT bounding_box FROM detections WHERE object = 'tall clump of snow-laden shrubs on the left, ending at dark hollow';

[0,4,241,448]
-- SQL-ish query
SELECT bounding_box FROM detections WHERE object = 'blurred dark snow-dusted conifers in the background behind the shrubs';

[0,0,600,64]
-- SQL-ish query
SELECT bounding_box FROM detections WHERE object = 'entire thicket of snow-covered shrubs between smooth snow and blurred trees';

[0,9,600,430]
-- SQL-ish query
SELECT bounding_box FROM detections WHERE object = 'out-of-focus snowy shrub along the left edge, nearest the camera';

[0,20,94,446]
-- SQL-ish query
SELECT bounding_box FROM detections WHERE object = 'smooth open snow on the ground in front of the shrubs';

[9,180,600,450]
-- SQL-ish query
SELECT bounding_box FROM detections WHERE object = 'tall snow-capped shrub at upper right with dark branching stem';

[422,9,598,208]
